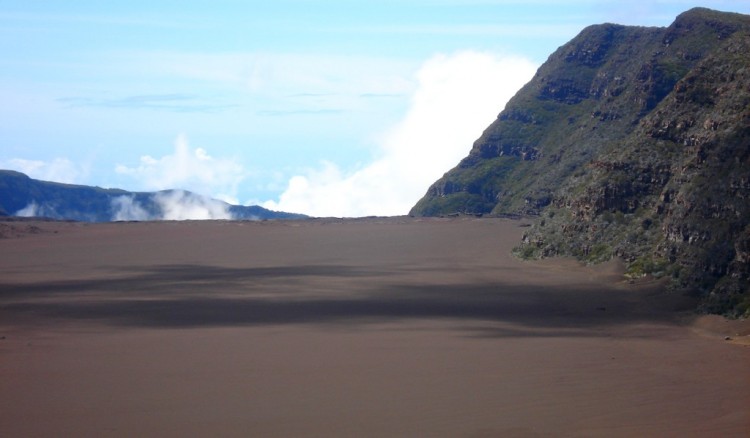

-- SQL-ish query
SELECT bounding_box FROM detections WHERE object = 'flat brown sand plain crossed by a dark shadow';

[0,218,750,437]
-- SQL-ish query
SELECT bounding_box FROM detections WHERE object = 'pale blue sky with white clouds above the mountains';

[0,0,750,217]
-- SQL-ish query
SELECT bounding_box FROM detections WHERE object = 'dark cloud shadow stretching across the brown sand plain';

[0,265,690,336]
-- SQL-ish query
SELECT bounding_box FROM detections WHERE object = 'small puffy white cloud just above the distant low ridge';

[115,135,247,204]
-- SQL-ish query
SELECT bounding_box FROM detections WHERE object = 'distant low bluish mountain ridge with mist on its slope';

[0,170,306,222]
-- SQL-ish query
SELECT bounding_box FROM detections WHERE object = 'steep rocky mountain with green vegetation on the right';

[411,8,750,316]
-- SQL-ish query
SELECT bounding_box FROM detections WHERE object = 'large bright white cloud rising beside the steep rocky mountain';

[264,51,537,217]
